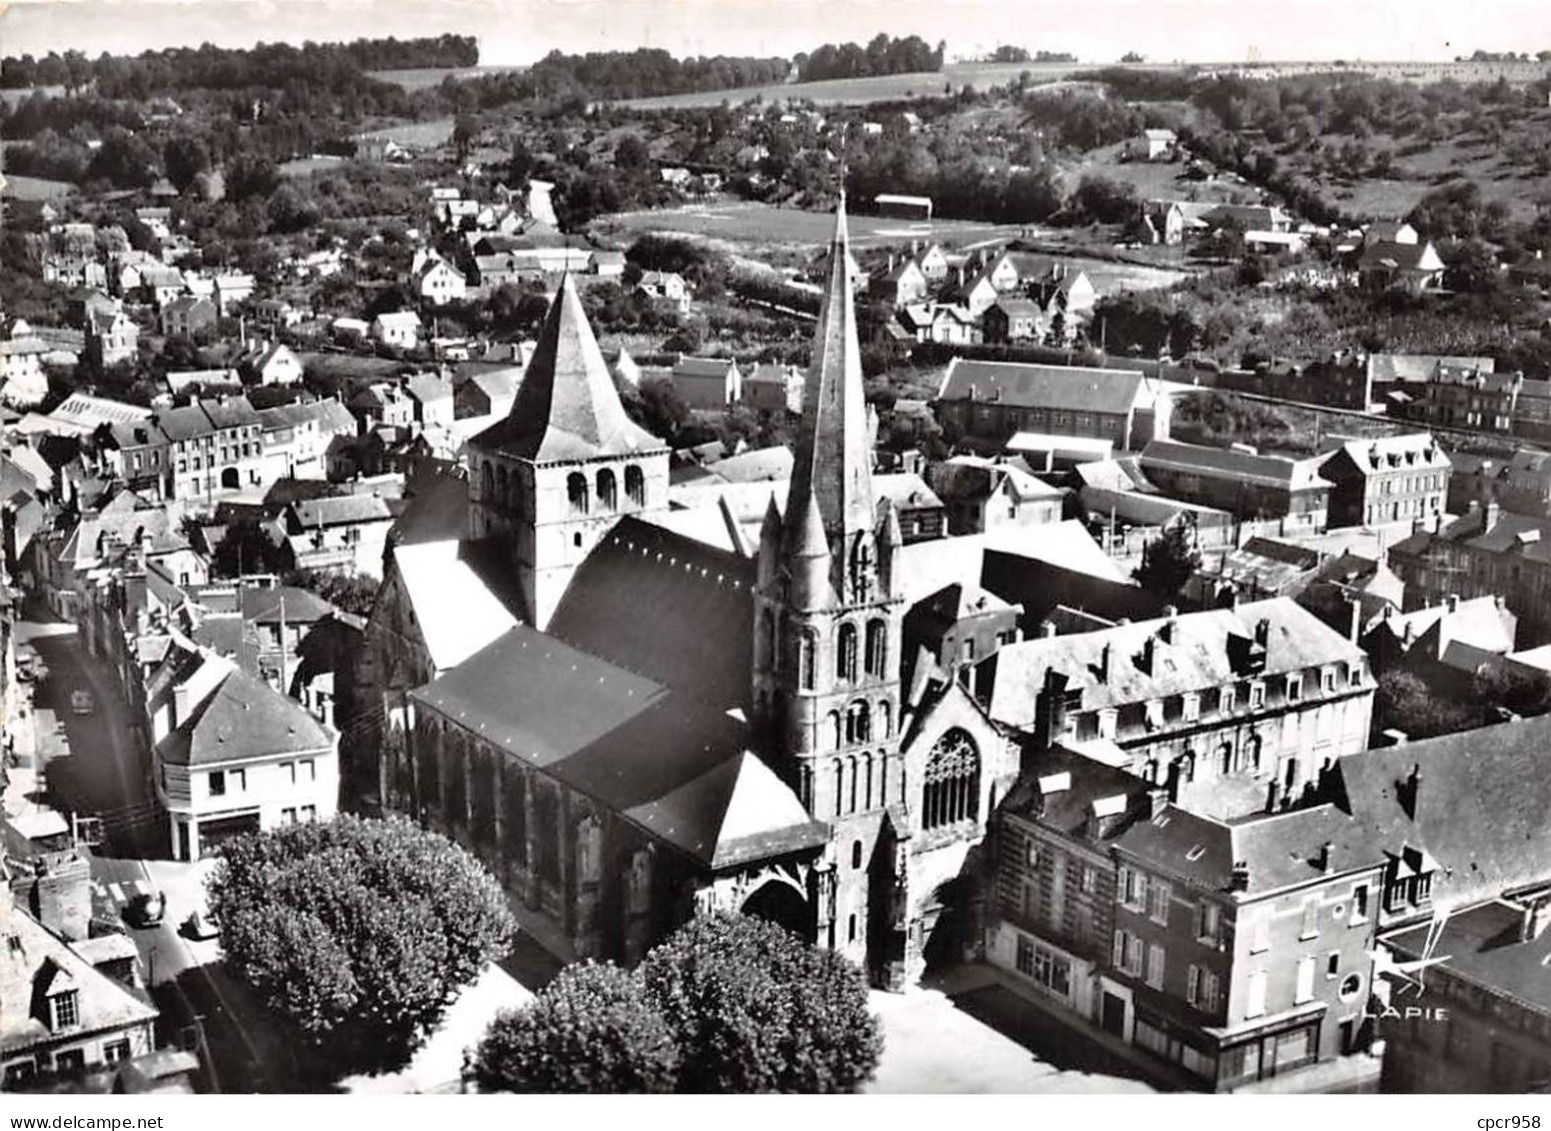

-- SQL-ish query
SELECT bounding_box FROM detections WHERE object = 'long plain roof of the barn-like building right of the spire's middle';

[937,357,1155,416]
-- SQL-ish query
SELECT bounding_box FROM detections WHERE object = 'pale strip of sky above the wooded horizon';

[0,0,1551,64]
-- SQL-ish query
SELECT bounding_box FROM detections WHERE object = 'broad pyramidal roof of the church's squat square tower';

[478,273,667,462]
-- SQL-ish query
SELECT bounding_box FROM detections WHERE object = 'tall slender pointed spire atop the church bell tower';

[786,192,875,546]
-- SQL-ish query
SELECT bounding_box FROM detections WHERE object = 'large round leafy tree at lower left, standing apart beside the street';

[209,816,513,1074]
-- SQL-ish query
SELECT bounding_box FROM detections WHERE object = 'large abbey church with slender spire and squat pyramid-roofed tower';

[366,202,1019,987]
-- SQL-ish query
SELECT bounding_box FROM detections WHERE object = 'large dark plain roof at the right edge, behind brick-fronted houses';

[1334,715,1551,909]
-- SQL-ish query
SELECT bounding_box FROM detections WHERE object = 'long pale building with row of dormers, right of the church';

[971,597,1376,816]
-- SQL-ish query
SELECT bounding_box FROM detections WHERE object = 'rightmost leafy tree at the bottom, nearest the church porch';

[641,914,883,1094]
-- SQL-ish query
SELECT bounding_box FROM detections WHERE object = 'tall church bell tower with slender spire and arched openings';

[754,195,904,962]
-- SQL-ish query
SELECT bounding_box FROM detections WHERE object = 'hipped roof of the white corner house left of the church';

[157,669,333,766]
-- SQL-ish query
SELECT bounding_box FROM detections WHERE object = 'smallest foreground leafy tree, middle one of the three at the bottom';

[465,962,679,1094]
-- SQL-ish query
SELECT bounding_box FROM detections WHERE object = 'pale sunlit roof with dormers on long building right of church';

[985,597,1363,728]
